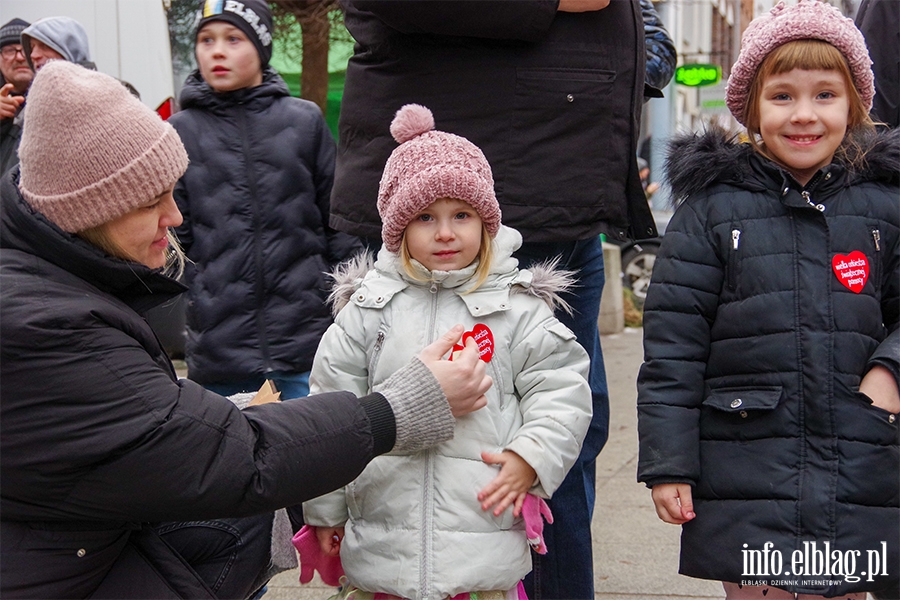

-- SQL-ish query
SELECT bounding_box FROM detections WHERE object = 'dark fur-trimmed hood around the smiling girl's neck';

[665,127,900,205]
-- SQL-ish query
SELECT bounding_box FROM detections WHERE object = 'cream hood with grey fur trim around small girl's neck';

[328,226,576,316]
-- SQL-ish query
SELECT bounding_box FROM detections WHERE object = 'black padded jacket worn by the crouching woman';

[0,168,384,598]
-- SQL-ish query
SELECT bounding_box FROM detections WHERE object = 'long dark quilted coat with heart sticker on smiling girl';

[638,127,900,597]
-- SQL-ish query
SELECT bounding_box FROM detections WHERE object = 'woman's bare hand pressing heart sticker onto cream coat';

[419,325,493,418]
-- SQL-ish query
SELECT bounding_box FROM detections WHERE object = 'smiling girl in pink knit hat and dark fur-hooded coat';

[638,0,900,599]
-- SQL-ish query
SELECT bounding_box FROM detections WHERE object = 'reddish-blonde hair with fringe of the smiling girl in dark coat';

[744,39,875,168]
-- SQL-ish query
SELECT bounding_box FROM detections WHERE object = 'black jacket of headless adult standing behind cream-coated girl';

[331,0,656,242]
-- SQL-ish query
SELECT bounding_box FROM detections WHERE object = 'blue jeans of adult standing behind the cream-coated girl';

[516,236,609,600]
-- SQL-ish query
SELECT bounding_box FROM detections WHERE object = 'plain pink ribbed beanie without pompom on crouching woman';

[19,60,188,233]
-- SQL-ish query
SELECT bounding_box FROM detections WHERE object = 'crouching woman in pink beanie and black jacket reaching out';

[0,61,489,598]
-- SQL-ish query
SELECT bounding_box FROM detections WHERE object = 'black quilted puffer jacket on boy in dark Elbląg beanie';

[169,68,361,383]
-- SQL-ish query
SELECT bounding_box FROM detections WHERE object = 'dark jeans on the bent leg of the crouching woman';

[156,513,273,599]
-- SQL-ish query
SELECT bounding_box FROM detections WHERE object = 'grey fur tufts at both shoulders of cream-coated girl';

[327,251,577,317]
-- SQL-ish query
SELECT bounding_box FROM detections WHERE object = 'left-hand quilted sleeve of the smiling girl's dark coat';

[638,204,724,487]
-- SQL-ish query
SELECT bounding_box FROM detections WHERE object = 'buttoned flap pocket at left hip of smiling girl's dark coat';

[700,386,783,439]
